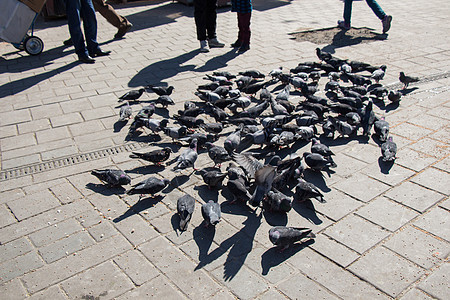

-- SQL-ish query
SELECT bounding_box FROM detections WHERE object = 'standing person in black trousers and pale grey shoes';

[194,0,225,52]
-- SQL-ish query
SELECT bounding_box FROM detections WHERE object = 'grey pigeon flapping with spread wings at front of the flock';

[249,155,280,207]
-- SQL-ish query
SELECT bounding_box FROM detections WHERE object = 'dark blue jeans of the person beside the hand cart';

[65,0,100,57]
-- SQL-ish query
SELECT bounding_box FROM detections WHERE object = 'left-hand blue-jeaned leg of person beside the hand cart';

[66,0,88,57]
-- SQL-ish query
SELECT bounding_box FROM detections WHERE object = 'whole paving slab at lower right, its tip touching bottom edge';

[348,247,424,297]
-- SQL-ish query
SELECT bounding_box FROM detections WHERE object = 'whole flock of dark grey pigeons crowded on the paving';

[92,48,418,250]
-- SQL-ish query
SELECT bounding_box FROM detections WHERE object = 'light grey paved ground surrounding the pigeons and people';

[0,0,450,299]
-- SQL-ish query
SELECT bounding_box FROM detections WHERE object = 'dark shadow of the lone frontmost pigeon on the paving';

[261,239,314,275]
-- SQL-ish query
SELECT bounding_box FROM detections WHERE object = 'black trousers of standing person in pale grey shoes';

[194,0,217,41]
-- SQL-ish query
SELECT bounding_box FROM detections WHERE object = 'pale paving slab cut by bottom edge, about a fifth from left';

[61,261,134,299]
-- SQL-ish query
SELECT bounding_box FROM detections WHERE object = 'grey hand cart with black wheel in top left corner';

[0,0,45,55]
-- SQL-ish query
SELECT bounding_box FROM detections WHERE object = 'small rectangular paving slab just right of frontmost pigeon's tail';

[310,234,359,267]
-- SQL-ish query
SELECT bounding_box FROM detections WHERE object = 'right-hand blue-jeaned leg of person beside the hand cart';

[80,0,100,56]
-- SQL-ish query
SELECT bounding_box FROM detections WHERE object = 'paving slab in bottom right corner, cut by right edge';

[419,262,450,299]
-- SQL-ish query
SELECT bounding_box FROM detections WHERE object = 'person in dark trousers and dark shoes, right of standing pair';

[231,0,253,53]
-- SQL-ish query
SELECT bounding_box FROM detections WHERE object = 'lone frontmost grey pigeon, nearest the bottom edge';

[269,226,316,251]
